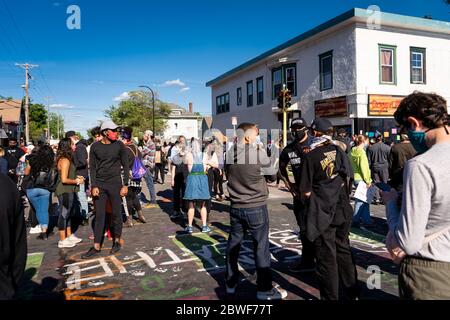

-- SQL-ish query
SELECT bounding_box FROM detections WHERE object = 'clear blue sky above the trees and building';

[0,0,450,134]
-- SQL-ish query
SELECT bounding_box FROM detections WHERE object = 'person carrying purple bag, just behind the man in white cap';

[122,127,147,227]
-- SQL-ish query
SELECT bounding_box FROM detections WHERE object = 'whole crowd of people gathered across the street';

[0,92,450,300]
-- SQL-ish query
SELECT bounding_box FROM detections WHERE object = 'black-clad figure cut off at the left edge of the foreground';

[0,174,27,300]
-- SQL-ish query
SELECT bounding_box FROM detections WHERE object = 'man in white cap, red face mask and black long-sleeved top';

[81,121,130,259]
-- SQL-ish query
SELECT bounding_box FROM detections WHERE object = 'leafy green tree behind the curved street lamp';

[105,91,171,138]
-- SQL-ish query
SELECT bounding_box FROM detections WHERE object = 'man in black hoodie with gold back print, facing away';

[300,119,359,300]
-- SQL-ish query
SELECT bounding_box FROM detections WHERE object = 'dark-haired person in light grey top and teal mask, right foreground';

[382,92,450,300]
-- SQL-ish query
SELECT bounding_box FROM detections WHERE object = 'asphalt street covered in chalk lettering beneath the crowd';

[19,181,398,300]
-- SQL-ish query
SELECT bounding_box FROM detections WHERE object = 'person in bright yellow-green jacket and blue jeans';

[350,135,372,228]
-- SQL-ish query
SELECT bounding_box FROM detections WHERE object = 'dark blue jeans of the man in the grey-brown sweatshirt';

[226,205,272,291]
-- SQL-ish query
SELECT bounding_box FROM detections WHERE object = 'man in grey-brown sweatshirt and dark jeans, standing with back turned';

[225,123,287,300]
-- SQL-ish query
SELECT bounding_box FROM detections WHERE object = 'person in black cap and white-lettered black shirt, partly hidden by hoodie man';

[279,118,315,272]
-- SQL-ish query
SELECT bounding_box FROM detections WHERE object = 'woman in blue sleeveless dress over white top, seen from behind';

[184,140,211,233]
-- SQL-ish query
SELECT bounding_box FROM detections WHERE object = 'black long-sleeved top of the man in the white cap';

[89,141,130,188]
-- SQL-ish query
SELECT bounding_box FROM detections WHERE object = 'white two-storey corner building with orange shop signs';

[207,8,450,141]
